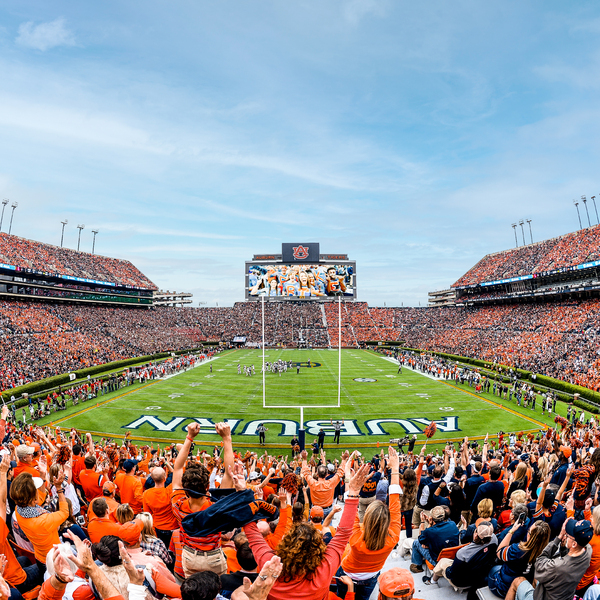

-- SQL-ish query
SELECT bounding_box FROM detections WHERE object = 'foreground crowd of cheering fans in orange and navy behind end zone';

[0,407,600,600]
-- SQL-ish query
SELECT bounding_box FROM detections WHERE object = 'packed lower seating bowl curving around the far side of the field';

[0,300,600,390]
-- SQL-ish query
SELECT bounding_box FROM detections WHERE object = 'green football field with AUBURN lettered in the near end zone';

[42,349,566,448]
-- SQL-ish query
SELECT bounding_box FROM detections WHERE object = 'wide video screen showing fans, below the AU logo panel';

[247,263,356,300]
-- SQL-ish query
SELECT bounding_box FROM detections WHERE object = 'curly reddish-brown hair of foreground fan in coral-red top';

[277,523,327,582]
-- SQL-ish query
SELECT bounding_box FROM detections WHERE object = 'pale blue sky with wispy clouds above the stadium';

[0,0,600,306]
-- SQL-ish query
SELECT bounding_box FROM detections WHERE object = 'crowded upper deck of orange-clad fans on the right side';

[451,225,600,289]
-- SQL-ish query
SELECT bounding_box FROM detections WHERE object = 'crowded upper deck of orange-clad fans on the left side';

[0,233,158,290]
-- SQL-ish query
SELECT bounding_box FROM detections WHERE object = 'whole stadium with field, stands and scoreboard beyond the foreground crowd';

[0,226,600,598]
